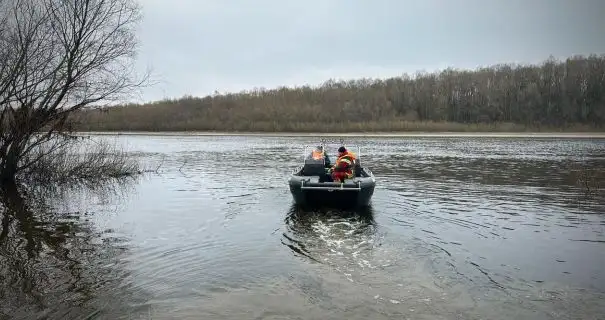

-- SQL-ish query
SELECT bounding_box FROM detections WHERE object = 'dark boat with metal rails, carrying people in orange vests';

[288,147,376,207]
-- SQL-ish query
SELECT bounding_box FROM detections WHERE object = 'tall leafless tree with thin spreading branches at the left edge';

[0,0,146,183]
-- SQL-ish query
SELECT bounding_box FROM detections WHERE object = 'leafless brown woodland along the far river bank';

[75,55,605,132]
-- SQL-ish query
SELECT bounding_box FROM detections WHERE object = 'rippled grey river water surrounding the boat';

[0,135,605,319]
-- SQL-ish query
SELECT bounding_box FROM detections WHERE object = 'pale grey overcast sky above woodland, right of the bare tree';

[133,0,605,101]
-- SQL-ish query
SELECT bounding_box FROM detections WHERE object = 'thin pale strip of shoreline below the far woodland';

[77,131,605,139]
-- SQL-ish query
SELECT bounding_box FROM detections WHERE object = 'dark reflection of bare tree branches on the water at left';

[0,181,146,319]
